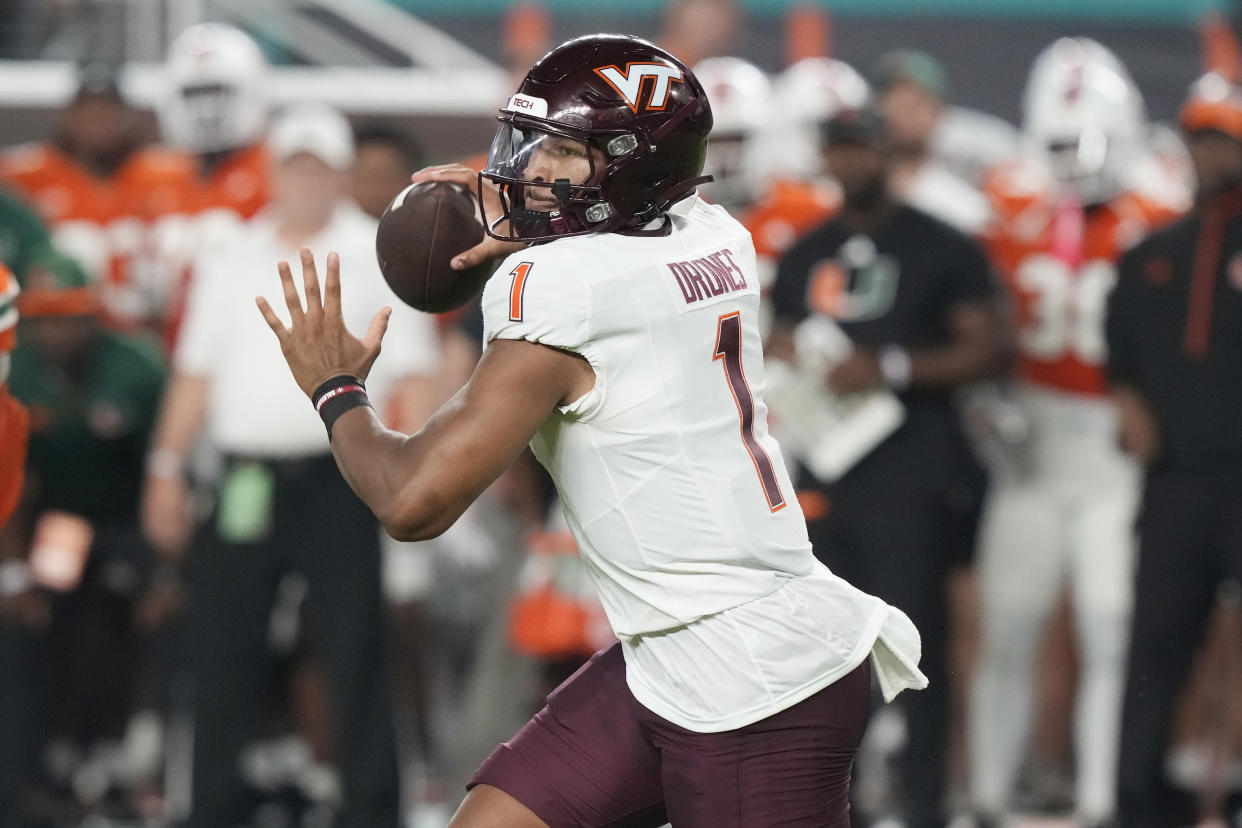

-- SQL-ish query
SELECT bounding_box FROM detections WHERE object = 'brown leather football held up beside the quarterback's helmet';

[375,181,494,313]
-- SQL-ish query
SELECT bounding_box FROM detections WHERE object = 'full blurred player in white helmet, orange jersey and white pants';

[970,38,1174,824]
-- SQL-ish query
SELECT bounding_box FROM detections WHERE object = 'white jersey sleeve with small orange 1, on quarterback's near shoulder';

[483,247,592,351]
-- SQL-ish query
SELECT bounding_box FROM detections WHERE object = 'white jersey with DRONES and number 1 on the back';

[483,197,922,731]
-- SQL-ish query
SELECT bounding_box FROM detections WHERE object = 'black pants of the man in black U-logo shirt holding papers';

[807,423,986,828]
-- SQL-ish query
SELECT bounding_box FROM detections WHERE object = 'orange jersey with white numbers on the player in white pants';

[985,164,1177,395]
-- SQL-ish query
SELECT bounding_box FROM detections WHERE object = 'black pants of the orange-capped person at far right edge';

[1118,469,1242,828]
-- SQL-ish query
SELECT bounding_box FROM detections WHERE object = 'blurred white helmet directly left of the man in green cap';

[769,57,871,179]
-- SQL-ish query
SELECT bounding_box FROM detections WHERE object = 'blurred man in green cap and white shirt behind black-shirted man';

[872,50,989,236]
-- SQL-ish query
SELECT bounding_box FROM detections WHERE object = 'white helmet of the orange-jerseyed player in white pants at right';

[1022,37,1146,204]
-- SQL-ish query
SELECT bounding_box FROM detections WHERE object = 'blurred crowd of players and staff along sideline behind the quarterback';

[0,0,1242,828]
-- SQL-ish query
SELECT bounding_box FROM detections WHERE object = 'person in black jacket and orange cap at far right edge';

[1108,76,1242,828]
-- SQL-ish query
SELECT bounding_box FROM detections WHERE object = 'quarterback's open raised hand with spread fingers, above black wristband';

[255,247,392,397]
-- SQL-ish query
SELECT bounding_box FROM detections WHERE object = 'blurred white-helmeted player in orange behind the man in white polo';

[153,24,270,348]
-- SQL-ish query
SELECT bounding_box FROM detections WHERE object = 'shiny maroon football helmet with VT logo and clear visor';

[479,35,712,241]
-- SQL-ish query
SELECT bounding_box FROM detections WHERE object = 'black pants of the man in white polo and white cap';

[188,456,399,828]
